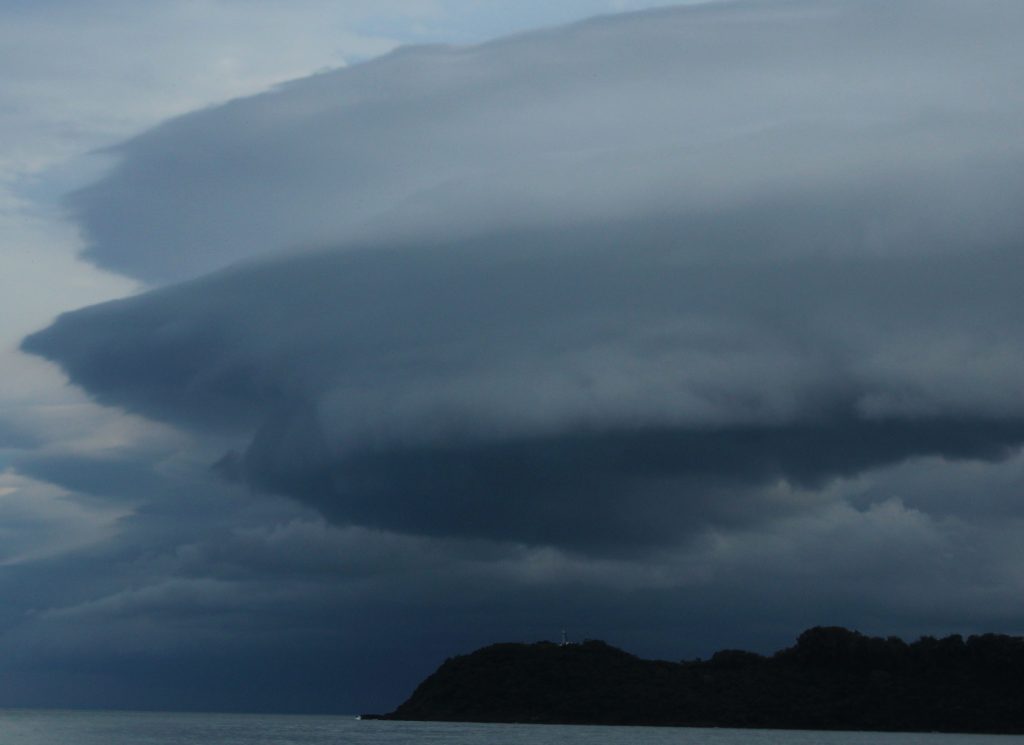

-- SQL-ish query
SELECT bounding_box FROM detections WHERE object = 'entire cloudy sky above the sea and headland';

[0,0,1024,713]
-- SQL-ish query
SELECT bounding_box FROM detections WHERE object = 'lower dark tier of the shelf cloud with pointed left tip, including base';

[26,212,1024,549]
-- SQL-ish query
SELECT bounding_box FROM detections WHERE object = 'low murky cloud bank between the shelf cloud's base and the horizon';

[0,421,1022,713]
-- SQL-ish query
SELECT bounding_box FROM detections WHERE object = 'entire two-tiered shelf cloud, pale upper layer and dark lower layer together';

[24,2,1024,552]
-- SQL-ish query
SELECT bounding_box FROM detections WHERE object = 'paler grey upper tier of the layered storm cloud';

[72,0,1024,281]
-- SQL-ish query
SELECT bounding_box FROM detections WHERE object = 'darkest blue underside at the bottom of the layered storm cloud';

[235,409,1024,551]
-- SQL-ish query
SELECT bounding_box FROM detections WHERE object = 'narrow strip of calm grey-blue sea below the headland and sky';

[0,709,1024,745]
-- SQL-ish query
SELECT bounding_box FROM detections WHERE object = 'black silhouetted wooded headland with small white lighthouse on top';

[365,627,1024,734]
